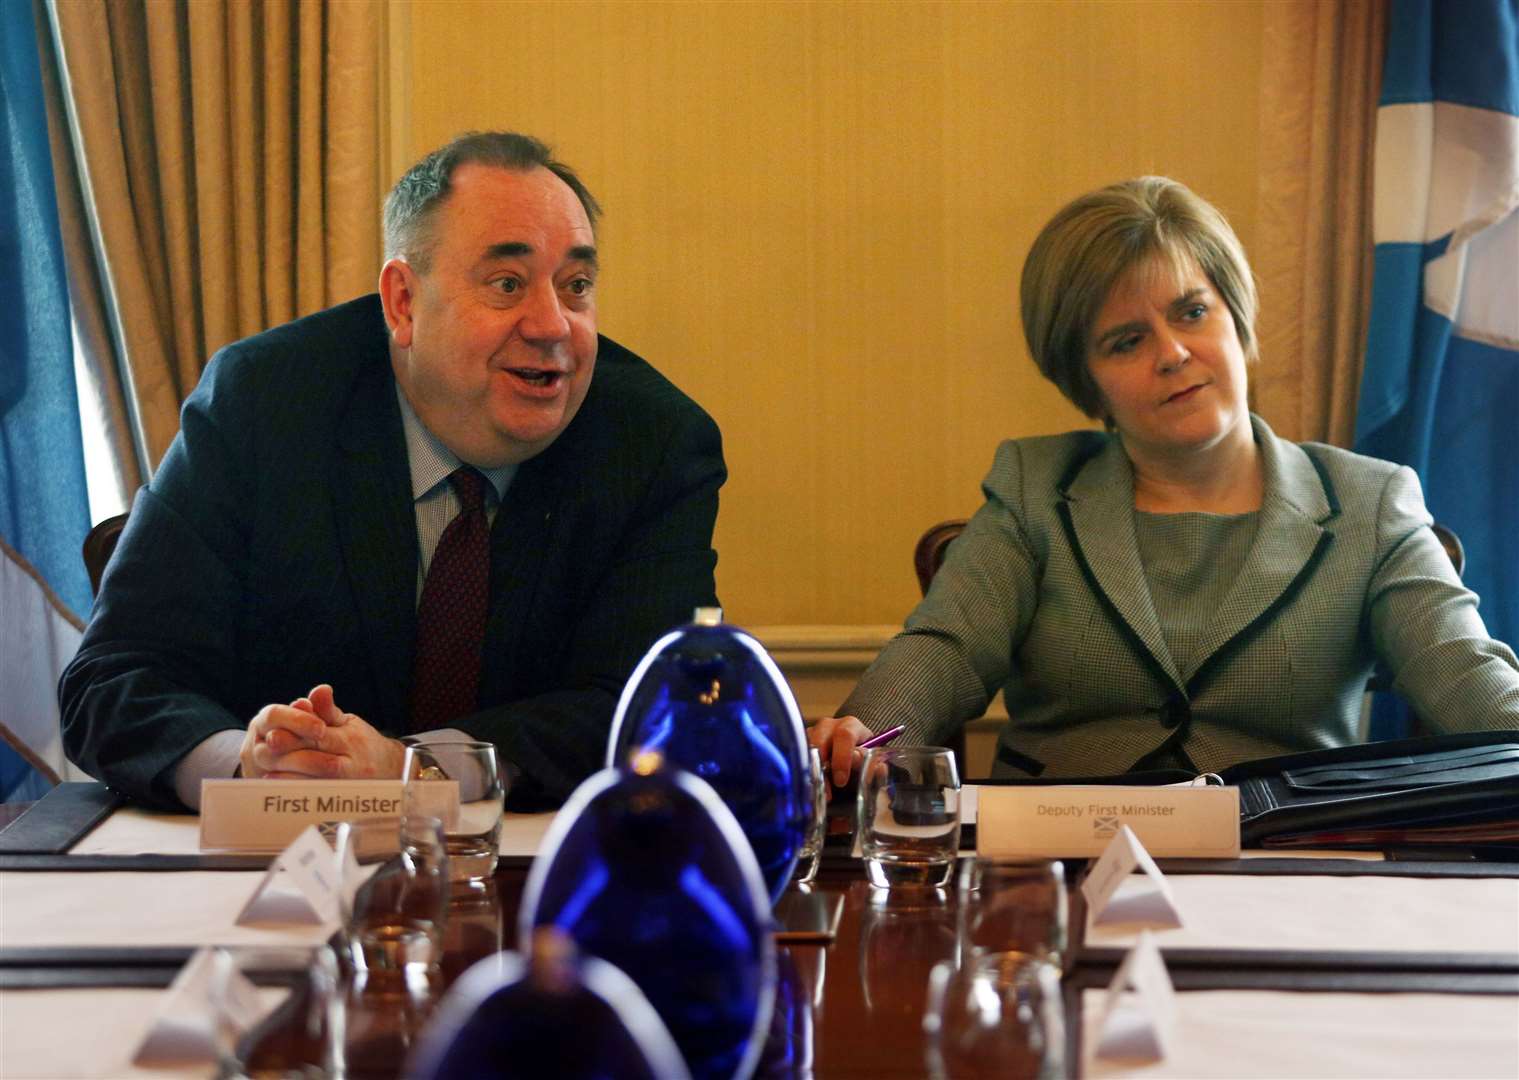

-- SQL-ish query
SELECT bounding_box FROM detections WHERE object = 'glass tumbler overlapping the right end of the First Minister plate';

[401,741,506,881]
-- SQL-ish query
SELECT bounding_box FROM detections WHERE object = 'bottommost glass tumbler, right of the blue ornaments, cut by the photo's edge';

[924,949,1065,1080]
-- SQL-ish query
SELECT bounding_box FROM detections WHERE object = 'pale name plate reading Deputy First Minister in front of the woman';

[975,784,1240,858]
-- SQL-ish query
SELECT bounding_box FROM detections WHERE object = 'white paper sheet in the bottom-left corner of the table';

[0,987,289,1080]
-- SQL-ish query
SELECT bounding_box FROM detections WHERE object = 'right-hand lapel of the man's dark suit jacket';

[480,448,565,706]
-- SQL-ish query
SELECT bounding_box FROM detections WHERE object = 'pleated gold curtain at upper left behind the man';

[49,0,381,475]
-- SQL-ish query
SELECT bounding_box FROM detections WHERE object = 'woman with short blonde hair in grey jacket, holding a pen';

[813,176,1519,784]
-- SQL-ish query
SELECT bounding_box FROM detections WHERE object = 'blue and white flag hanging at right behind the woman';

[1355,0,1519,674]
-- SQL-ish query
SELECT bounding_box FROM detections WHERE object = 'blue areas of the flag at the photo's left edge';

[0,0,90,799]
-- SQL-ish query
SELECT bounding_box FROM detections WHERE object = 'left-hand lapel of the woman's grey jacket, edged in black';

[1060,439,1182,687]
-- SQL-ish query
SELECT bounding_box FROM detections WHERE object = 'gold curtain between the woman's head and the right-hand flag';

[1252,0,1387,447]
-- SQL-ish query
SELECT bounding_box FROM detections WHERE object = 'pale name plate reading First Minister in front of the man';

[201,779,459,852]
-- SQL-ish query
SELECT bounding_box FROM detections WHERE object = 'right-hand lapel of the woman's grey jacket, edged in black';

[1186,416,1338,682]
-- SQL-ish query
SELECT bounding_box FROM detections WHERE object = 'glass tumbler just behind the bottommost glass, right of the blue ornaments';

[960,857,1068,969]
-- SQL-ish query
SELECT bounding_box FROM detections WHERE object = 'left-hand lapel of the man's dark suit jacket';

[333,358,418,732]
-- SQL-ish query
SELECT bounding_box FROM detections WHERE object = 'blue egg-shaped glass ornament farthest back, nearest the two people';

[606,608,813,904]
